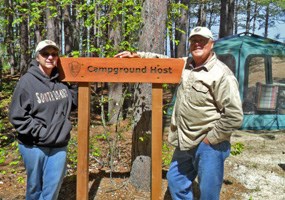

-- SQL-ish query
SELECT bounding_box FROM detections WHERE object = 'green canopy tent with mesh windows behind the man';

[214,33,285,130]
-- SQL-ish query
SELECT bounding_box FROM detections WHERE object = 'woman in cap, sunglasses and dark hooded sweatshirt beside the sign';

[9,40,77,200]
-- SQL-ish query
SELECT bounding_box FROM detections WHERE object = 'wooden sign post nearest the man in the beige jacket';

[151,83,163,200]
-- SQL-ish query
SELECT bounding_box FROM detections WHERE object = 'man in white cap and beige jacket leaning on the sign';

[116,27,243,200]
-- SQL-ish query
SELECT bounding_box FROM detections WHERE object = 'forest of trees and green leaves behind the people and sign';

[0,0,285,198]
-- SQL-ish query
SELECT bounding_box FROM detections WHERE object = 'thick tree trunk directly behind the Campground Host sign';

[132,0,167,191]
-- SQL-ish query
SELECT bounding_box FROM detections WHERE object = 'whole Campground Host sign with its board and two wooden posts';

[59,57,184,200]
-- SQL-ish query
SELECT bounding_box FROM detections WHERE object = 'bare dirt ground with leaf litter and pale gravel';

[0,126,285,200]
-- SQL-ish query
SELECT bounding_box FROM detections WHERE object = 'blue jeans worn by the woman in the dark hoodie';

[19,144,67,200]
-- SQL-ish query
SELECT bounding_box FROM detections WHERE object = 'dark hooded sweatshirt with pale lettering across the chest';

[9,60,77,147]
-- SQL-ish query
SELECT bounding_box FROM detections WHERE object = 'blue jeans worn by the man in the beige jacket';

[167,141,231,200]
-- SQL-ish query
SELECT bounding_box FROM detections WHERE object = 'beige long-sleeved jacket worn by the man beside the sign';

[138,52,243,150]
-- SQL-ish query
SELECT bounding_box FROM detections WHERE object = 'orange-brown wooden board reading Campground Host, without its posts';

[59,57,184,83]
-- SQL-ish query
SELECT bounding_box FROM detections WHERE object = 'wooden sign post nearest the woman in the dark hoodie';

[76,83,90,200]
